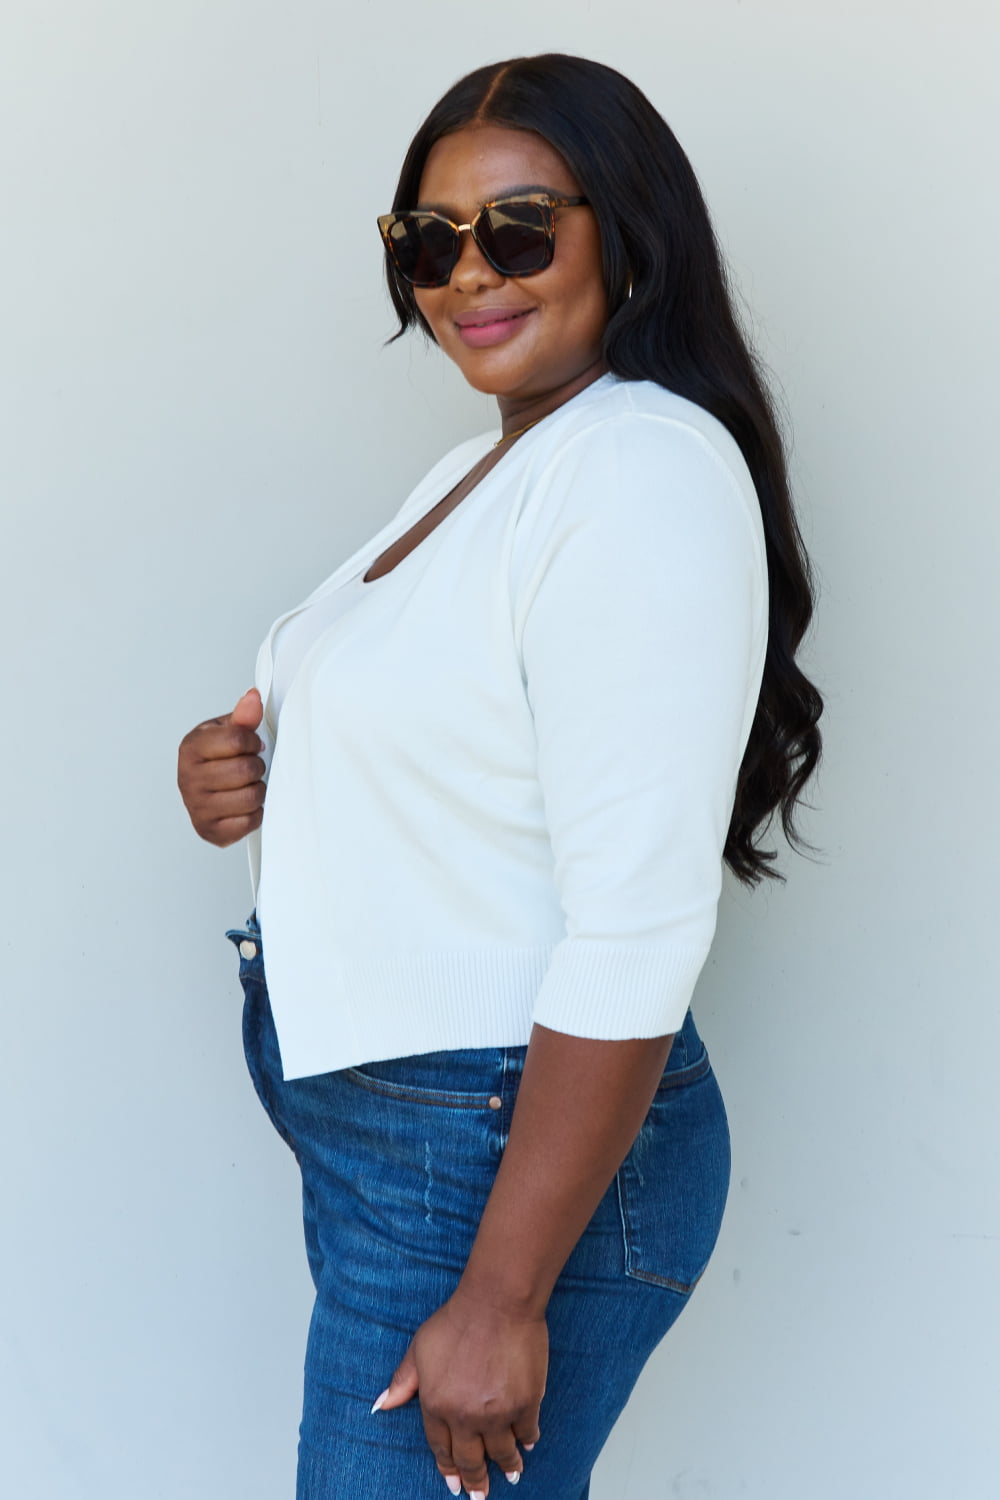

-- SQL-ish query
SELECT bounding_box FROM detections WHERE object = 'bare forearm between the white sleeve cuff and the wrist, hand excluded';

[462,1026,673,1317]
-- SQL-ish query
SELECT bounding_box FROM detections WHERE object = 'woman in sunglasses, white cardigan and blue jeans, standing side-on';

[178,56,822,1500]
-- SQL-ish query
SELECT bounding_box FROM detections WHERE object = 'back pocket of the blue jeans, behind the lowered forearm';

[618,1053,730,1293]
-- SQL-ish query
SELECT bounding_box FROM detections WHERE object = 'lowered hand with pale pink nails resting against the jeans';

[378,1287,549,1496]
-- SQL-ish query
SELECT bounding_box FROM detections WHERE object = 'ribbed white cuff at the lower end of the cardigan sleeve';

[532,938,709,1041]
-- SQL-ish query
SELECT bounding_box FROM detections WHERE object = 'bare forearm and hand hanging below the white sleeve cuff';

[381,1026,673,1494]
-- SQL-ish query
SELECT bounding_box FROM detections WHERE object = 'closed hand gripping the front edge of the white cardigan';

[177,687,264,849]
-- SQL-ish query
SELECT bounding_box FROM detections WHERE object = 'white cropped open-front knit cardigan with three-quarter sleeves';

[250,375,768,1079]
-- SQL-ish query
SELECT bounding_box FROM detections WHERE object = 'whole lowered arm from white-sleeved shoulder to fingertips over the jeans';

[374,417,766,1494]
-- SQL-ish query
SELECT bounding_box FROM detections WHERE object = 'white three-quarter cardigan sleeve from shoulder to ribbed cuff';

[511,413,768,1040]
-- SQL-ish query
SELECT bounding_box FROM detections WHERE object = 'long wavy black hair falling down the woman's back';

[385,53,823,885]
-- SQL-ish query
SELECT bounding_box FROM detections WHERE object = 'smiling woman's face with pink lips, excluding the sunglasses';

[414,125,607,411]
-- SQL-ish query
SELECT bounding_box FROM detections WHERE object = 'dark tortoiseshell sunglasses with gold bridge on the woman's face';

[378,192,588,287]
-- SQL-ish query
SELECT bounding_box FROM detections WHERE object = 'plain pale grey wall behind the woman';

[0,0,1000,1500]
